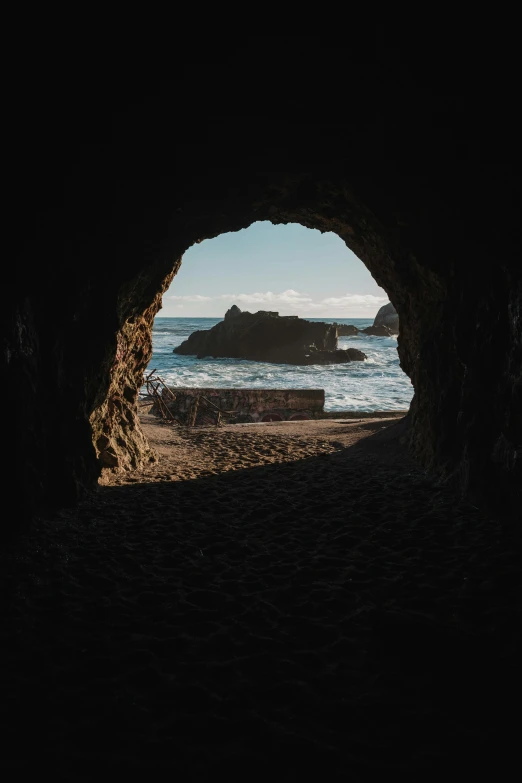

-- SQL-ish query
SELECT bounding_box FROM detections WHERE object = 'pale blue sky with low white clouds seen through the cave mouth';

[158,221,389,318]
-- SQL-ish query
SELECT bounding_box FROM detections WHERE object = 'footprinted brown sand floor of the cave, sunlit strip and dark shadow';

[0,415,522,783]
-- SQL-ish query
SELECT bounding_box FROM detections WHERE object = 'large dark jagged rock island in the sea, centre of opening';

[174,305,366,364]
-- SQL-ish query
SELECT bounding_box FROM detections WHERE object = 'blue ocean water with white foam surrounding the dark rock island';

[146,316,413,412]
